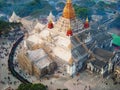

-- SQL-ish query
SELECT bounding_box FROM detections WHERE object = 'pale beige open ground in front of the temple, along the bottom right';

[35,71,120,90]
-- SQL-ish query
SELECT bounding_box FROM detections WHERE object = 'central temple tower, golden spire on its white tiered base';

[55,0,84,36]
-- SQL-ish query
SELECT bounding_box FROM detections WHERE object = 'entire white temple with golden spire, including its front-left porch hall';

[13,0,117,78]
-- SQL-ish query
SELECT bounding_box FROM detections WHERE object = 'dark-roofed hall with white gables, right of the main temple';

[87,47,116,77]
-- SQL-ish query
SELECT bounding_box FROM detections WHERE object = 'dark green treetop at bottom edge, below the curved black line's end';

[17,83,47,90]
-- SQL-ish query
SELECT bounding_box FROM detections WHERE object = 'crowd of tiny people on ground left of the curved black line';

[0,30,23,88]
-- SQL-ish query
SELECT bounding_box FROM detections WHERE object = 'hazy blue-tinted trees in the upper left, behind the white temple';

[0,0,52,17]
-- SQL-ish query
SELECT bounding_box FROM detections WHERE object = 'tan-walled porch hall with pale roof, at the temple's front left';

[18,49,57,78]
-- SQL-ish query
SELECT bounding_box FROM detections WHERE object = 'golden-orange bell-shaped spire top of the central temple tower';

[63,0,75,19]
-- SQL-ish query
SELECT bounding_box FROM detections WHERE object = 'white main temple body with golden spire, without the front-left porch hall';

[17,0,92,76]
